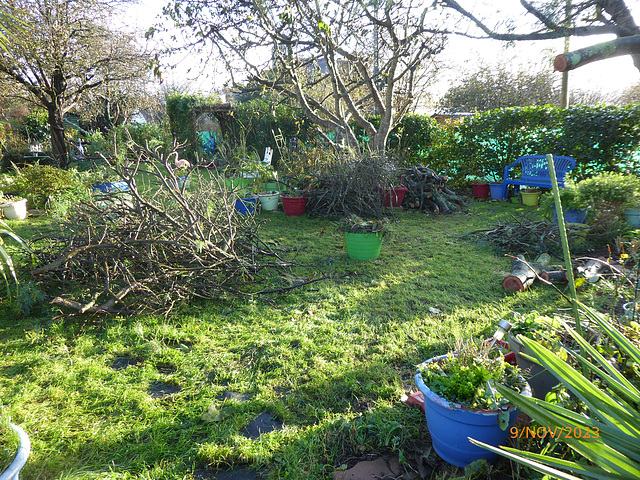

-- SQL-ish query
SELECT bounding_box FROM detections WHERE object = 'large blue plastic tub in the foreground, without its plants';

[415,355,531,468]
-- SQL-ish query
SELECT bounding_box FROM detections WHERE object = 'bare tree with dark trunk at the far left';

[0,0,149,166]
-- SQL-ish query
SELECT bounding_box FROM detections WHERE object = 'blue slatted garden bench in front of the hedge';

[502,155,576,199]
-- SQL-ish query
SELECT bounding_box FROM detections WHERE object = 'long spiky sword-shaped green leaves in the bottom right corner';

[474,301,640,480]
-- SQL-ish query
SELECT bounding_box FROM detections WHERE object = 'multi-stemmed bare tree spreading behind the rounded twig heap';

[165,0,444,152]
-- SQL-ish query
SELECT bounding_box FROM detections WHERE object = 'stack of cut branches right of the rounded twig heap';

[400,167,466,214]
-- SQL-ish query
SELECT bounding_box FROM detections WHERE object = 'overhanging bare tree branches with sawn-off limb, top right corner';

[437,0,640,71]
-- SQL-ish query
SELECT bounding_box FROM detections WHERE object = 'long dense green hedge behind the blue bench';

[428,105,640,184]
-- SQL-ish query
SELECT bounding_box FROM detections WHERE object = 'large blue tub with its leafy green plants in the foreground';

[415,342,531,467]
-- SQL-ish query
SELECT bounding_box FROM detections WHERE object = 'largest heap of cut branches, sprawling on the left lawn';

[32,142,320,315]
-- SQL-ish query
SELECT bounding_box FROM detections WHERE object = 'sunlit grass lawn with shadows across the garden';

[0,202,576,480]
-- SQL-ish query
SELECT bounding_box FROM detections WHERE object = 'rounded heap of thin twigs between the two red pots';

[306,156,395,218]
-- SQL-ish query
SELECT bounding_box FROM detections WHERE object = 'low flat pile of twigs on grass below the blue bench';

[466,216,589,254]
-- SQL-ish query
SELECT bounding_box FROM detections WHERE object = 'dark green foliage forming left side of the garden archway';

[167,93,220,161]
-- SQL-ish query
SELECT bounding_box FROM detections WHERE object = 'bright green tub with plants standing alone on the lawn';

[339,215,387,260]
